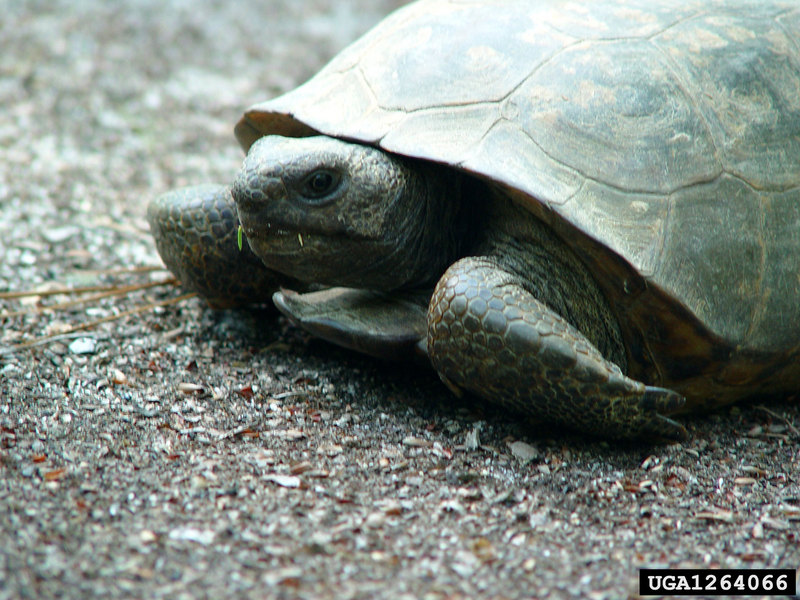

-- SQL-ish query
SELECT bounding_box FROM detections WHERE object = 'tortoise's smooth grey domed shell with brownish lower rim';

[236,0,800,403]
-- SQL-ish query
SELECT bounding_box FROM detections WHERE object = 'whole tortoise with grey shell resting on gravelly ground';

[148,0,800,440]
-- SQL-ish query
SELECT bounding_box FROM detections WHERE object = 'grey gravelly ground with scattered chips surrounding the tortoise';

[0,0,800,600]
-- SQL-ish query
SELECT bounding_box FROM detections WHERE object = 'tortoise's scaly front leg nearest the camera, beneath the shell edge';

[428,257,686,439]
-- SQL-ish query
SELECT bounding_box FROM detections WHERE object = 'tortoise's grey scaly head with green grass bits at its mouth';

[232,136,457,290]
